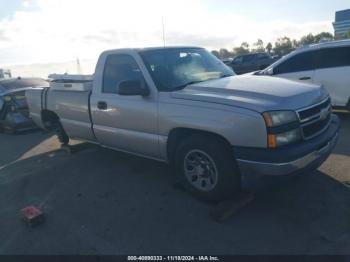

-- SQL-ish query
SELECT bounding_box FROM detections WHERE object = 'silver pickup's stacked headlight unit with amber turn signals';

[263,111,301,148]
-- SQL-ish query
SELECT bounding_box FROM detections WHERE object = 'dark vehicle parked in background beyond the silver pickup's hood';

[225,53,277,75]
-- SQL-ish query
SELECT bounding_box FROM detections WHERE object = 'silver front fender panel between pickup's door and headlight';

[159,104,267,159]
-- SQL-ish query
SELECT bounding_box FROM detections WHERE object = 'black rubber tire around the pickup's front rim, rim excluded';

[174,135,241,201]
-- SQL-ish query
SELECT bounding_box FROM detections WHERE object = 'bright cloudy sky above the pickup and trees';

[0,0,350,76]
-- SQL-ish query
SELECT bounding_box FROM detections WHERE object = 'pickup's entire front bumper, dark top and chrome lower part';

[234,115,340,186]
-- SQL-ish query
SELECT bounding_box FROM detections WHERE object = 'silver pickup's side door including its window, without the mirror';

[90,53,159,158]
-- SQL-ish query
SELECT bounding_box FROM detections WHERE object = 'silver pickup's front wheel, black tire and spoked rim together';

[175,135,241,201]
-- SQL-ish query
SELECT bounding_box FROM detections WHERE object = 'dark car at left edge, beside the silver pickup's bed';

[0,77,48,133]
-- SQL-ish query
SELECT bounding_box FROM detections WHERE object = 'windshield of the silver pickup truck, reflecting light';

[140,48,234,92]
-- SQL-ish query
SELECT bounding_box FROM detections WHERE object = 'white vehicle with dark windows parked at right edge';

[255,40,350,110]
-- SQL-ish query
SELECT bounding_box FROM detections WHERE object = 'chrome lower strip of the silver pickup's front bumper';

[237,133,339,176]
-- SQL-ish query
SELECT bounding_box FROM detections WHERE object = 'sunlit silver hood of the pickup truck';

[171,75,328,112]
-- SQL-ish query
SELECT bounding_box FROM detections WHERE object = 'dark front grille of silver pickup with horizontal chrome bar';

[298,98,332,140]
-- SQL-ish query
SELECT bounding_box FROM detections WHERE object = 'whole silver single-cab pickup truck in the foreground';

[26,47,339,200]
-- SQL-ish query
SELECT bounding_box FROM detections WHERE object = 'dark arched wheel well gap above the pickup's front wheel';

[167,128,232,162]
